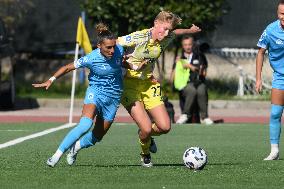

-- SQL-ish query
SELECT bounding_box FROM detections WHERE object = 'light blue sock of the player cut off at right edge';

[269,104,283,144]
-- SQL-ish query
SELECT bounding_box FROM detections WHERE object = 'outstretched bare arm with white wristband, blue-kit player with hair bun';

[32,63,76,90]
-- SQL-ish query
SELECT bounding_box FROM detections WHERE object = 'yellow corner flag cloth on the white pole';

[76,17,92,54]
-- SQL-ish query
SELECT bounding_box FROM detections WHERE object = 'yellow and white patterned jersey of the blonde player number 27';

[117,29,175,79]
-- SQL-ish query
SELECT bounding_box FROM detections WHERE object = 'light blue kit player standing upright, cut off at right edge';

[255,0,284,160]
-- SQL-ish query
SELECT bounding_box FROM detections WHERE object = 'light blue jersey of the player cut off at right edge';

[257,20,284,75]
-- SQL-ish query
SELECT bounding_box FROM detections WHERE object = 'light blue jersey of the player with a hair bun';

[74,45,123,99]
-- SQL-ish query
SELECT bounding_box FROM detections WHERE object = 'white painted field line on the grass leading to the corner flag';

[0,123,76,149]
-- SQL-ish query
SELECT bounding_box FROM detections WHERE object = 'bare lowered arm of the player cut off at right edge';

[255,48,266,93]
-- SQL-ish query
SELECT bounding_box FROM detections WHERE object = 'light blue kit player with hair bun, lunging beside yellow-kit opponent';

[33,24,123,167]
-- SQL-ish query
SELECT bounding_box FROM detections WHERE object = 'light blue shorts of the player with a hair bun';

[84,86,120,122]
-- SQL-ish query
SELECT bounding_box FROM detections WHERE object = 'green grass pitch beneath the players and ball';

[0,123,284,189]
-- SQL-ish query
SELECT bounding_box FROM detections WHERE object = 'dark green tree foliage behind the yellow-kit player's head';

[79,0,228,77]
